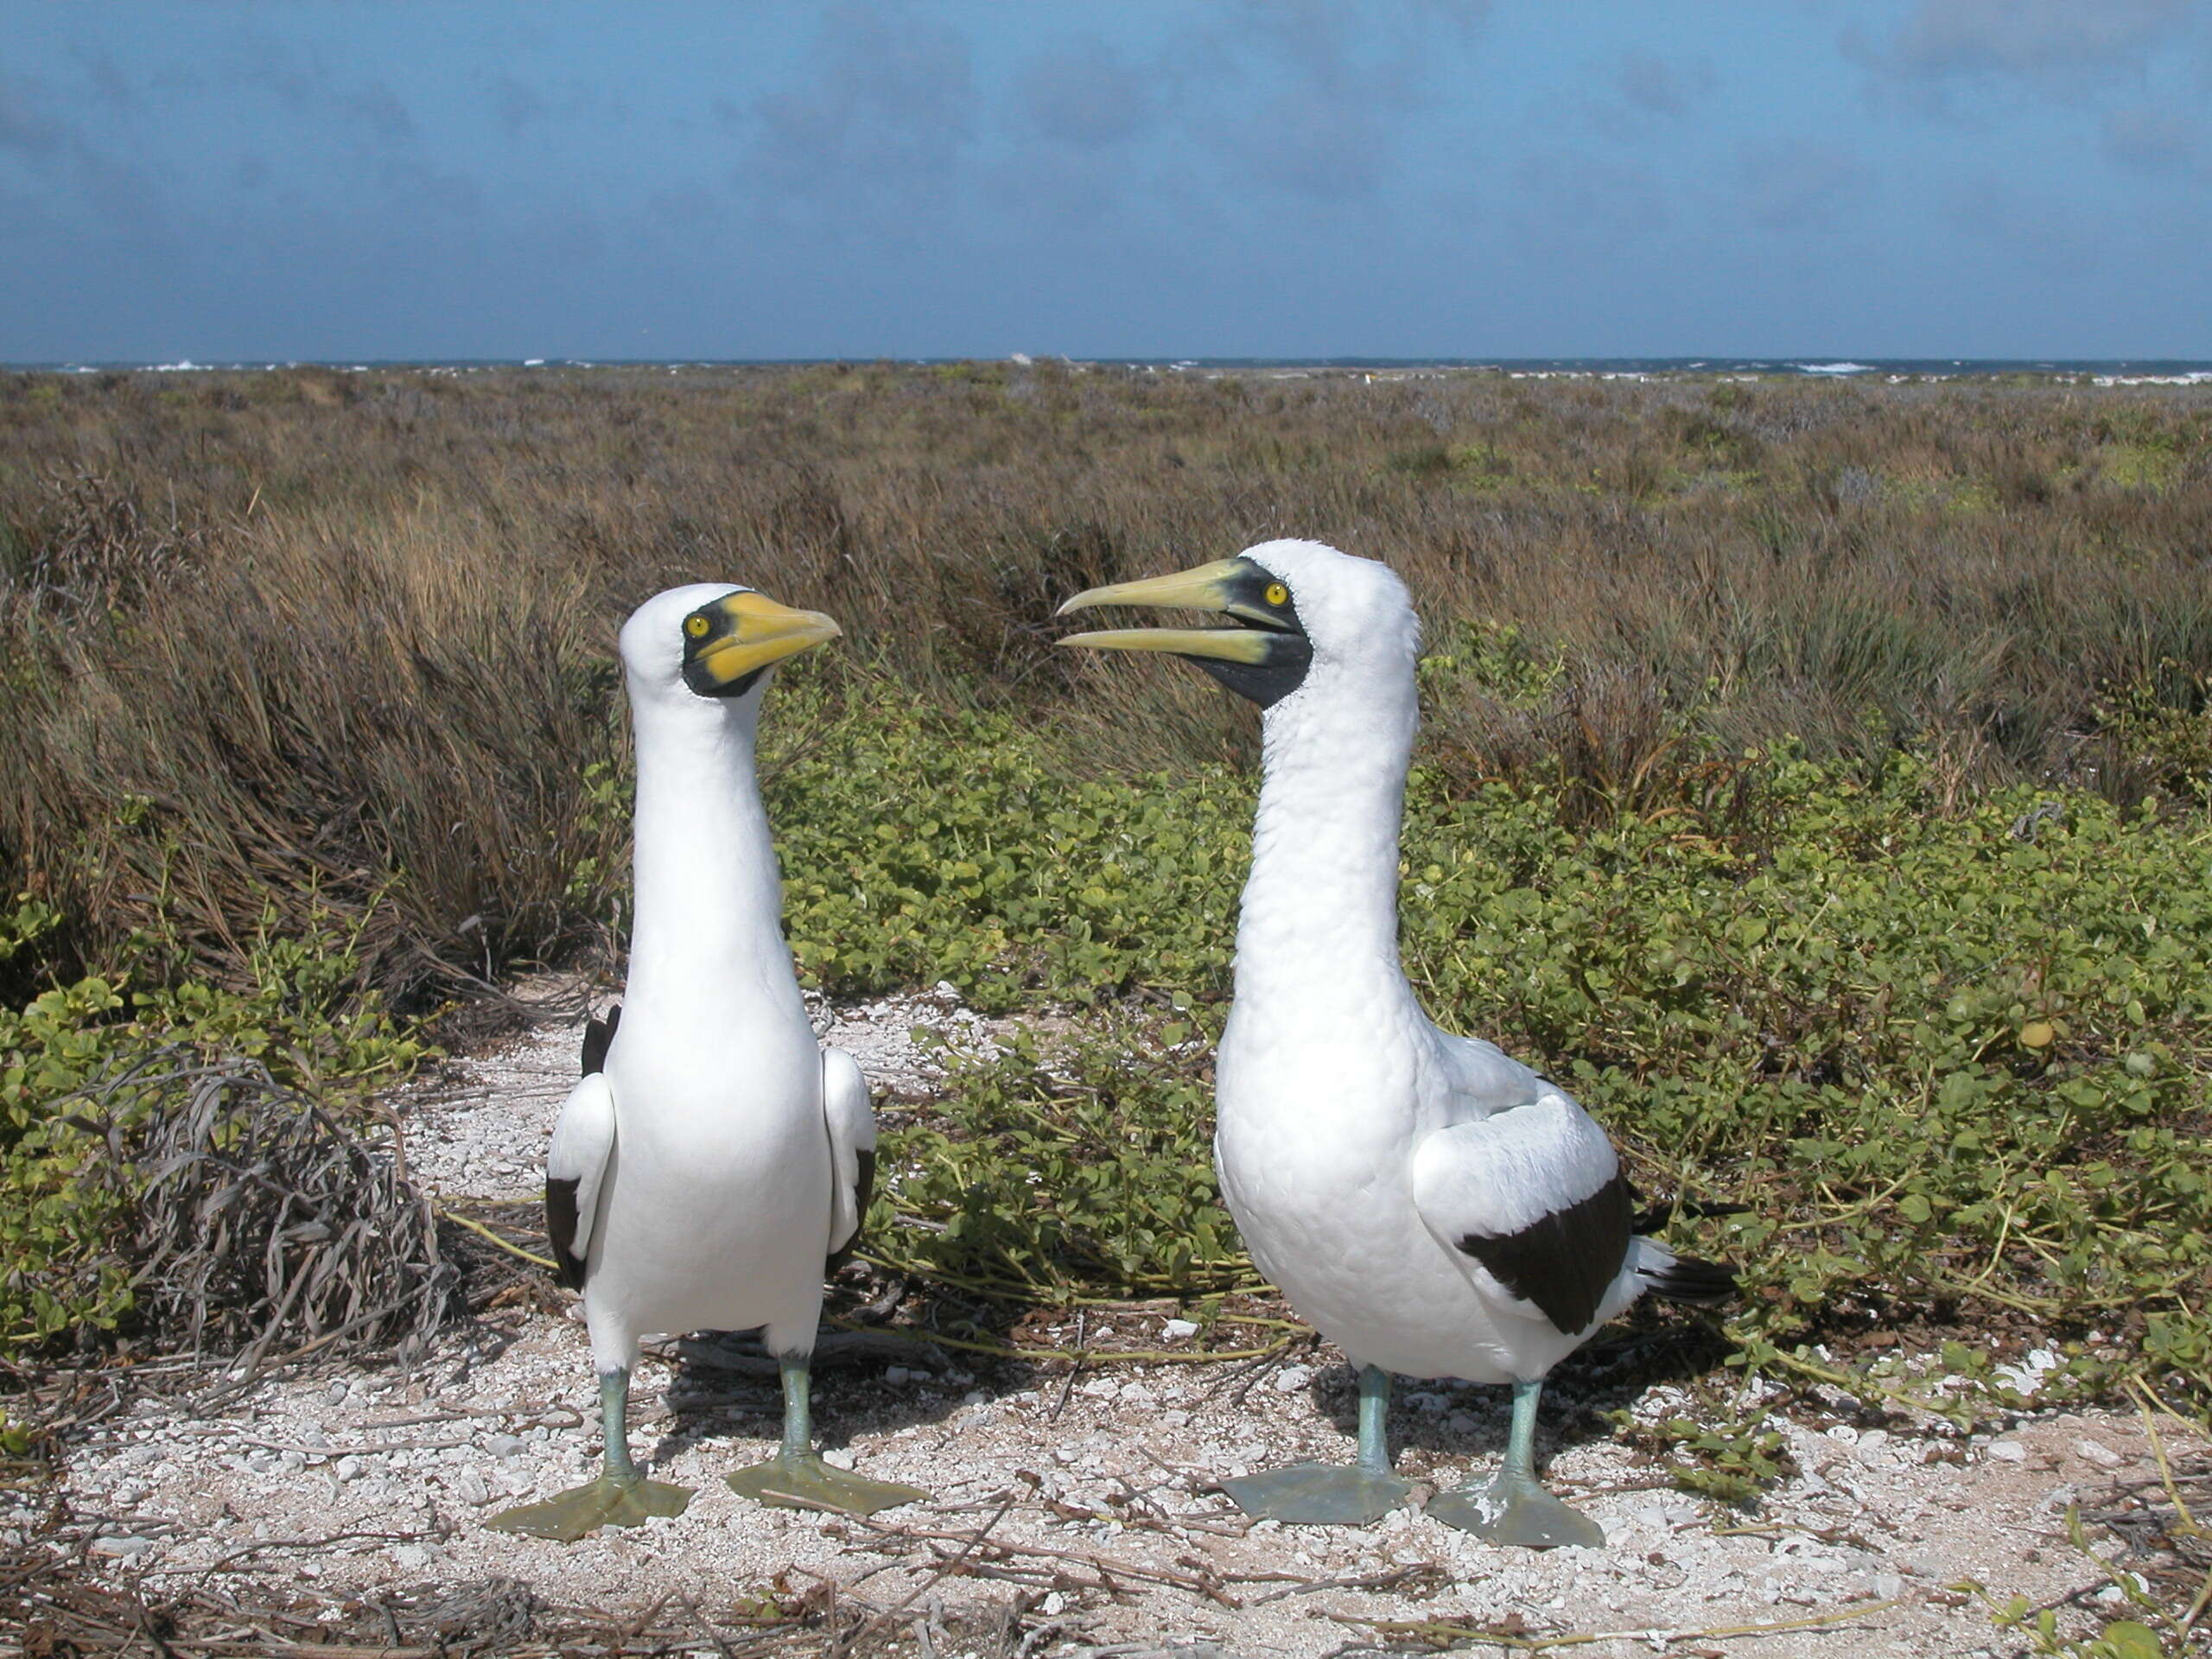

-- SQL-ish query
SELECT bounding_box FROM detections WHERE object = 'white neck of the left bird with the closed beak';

[626,696,798,1007]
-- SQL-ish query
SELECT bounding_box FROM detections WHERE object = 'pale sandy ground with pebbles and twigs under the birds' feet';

[26,993,2201,1659]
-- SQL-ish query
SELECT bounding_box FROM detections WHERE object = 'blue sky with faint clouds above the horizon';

[0,0,2212,363]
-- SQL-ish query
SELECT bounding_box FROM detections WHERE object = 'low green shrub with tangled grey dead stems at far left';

[0,902,427,1354]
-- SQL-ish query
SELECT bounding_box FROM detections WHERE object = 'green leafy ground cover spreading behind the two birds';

[0,681,2212,1433]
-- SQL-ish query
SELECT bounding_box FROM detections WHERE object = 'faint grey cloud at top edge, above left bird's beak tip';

[743,4,976,201]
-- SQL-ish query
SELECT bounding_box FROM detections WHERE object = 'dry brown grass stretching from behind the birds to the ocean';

[0,365,2212,988]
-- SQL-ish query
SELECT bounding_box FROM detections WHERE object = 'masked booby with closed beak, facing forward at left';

[491,584,925,1541]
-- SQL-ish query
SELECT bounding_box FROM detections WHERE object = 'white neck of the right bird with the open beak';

[1236,675,1418,1031]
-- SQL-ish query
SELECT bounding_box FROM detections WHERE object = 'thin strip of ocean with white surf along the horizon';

[17,352,2212,387]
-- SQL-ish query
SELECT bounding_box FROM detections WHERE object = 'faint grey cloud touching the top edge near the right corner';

[1842,0,2199,102]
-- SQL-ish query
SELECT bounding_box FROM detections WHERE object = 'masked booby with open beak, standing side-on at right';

[1059,553,1734,1546]
